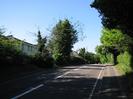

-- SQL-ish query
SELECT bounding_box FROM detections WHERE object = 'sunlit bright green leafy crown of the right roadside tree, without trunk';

[100,28,133,51]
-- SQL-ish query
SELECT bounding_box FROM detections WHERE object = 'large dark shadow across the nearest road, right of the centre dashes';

[20,72,133,99]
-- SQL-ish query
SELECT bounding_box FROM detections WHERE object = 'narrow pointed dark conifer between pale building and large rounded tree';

[34,31,54,68]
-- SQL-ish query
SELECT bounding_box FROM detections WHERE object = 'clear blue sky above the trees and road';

[0,0,102,52]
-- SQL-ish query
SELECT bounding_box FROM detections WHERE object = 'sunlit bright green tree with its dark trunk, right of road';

[97,28,132,64]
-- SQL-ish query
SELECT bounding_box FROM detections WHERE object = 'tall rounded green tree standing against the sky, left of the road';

[49,19,78,64]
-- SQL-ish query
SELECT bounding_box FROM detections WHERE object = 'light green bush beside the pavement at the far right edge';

[117,51,133,90]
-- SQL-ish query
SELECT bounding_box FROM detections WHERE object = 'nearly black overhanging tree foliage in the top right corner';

[91,0,133,37]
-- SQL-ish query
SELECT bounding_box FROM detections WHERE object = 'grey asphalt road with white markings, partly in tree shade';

[0,64,127,99]
